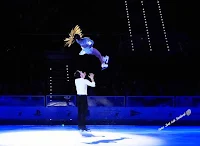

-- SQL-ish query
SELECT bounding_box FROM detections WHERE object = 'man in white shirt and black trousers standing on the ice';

[74,70,95,131]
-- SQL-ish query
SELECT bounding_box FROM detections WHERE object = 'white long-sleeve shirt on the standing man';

[75,78,96,95]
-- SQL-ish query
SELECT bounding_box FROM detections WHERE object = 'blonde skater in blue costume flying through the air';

[64,25,109,70]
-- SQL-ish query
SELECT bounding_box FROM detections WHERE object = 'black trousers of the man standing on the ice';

[76,95,88,129]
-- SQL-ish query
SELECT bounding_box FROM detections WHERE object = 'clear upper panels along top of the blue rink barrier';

[0,95,200,107]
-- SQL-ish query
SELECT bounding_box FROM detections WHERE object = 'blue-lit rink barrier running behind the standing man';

[0,95,200,124]
